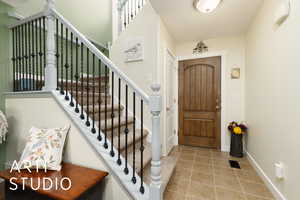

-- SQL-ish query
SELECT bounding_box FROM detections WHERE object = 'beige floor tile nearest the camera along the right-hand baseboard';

[240,181,273,198]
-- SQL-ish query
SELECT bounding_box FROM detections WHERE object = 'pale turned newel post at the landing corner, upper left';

[43,0,57,91]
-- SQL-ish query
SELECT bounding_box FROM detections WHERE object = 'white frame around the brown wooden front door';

[175,51,229,152]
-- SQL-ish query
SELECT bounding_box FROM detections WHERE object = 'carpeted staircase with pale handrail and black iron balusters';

[10,0,176,200]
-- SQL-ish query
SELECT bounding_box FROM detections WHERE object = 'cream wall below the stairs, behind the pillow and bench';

[6,94,131,200]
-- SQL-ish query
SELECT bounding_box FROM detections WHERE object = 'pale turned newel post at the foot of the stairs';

[150,84,162,200]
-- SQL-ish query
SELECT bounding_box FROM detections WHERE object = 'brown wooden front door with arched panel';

[179,57,221,149]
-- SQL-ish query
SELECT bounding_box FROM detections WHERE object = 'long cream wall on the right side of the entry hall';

[246,0,300,200]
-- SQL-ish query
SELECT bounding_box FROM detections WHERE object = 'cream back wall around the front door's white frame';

[176,36,245,151]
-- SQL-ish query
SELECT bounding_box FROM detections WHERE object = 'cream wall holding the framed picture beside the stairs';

[110,2,160,141]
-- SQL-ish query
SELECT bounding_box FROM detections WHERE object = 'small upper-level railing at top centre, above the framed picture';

[118,0,146,33]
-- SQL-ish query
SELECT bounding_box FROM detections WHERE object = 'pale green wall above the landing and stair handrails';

[10,0,112,44]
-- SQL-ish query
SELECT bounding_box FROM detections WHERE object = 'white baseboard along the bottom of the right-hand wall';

[246,151,287,200]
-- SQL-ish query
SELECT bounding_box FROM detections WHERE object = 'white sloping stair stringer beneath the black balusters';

[52,91,150,200]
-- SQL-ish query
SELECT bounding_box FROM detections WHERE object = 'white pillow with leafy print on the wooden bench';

[19,126,70,171]
